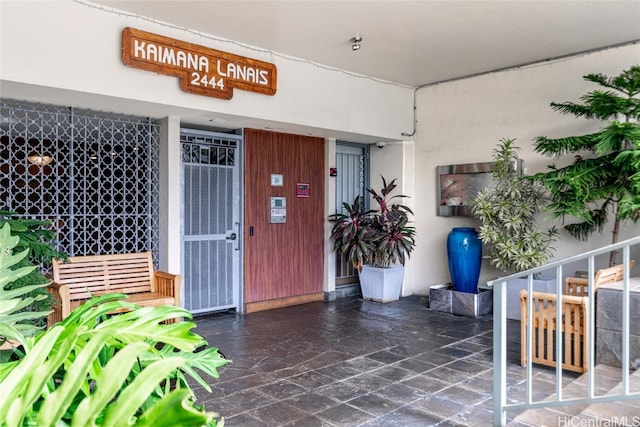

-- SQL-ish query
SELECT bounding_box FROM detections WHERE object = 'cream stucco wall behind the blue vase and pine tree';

[407,45,640,294]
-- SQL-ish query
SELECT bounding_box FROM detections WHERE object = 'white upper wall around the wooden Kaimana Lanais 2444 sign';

[0,0,413,139]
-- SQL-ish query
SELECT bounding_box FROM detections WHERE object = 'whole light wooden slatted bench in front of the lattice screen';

[47,252,182,326]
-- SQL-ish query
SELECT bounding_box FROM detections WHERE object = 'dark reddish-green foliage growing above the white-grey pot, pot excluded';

[329,177,416,271]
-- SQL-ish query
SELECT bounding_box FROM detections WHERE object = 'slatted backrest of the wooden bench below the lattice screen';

[52,252,154,301]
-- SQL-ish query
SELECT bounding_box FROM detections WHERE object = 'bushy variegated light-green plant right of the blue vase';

[470,138,557,272]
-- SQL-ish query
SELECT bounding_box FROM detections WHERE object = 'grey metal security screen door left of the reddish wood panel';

[180,129,242,314]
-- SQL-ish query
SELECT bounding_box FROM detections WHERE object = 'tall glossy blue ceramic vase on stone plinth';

[447,227,482,294]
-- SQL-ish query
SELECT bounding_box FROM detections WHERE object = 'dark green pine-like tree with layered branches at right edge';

[533,65,640,265]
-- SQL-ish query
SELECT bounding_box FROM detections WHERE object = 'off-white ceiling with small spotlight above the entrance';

[93,0,640,87]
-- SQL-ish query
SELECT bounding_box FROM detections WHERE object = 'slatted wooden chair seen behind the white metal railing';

[520,261,633,372]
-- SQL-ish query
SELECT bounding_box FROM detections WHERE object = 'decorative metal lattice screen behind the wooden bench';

[0,100,160,262]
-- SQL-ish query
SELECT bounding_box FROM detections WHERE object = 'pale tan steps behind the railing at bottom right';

[509,364,640,427]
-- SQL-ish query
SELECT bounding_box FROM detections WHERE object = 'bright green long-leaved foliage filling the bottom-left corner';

[0,225,229,427]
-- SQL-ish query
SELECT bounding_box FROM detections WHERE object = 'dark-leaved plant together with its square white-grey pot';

[329,176,416,302]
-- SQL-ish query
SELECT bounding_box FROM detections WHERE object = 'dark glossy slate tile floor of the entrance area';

[195,296,564,427]
